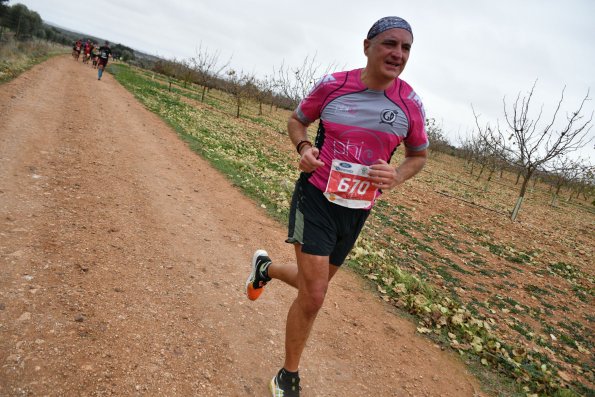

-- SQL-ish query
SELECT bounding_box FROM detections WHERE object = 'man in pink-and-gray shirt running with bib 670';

[246,17,428,397]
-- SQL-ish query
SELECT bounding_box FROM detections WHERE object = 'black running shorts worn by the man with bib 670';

[286,173,370,266]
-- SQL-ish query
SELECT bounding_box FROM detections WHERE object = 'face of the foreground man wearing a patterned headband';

[364,29,413,80]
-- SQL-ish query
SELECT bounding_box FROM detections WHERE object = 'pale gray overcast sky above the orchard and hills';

[9,0,595,163]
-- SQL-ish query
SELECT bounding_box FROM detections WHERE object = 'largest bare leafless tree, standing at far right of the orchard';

[473,81,593,220]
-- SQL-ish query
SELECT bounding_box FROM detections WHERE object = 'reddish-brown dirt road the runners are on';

[0,57,478,397]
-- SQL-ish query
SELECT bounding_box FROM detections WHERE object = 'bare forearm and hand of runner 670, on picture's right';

[370,149,428,191]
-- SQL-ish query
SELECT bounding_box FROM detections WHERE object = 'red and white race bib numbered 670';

[324,160,378,208]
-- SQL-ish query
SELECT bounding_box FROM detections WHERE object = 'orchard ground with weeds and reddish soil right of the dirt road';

[109,64,595,396]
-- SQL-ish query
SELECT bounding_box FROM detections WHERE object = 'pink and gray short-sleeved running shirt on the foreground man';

[296,69,428,201]
